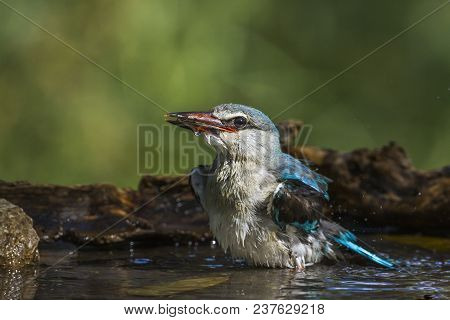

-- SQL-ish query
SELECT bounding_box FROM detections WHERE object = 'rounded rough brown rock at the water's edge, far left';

[0,199,39,269]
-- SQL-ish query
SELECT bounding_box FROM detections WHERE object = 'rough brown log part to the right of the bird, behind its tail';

[291,143,450,235]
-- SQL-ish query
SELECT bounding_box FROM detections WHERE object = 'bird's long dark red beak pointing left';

[165,112,237,133]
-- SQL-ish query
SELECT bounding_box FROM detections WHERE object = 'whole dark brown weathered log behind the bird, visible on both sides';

[0,121,450,245]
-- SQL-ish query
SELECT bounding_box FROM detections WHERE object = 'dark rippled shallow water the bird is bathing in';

[0,237,450,299]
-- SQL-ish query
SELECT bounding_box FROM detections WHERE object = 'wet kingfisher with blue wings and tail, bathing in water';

[165,103,395,270]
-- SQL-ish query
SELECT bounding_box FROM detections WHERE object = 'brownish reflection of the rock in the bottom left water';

[0,267,37,300]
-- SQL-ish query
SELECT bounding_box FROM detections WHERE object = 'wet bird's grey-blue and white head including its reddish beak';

[166,104,280,162]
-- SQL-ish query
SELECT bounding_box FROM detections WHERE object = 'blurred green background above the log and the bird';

[0,0,450,186]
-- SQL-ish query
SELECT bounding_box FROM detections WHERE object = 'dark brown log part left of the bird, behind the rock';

[0,177,210,244]
